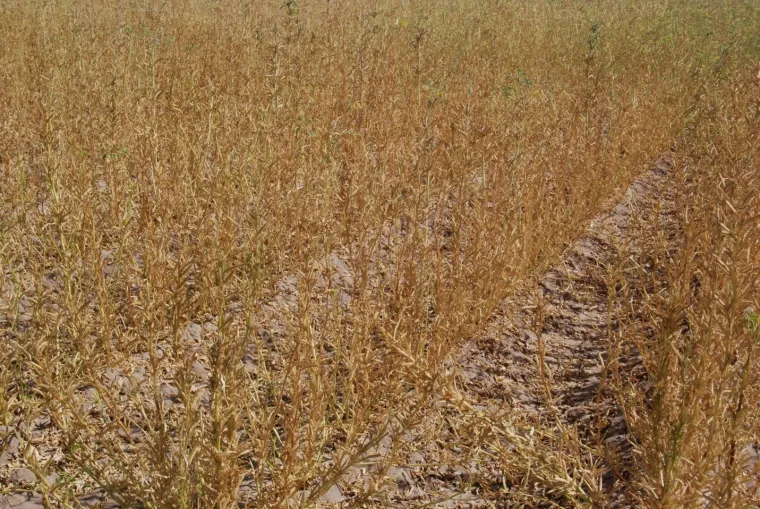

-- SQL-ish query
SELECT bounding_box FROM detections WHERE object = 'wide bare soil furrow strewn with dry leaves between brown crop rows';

[325,153,673,508]
